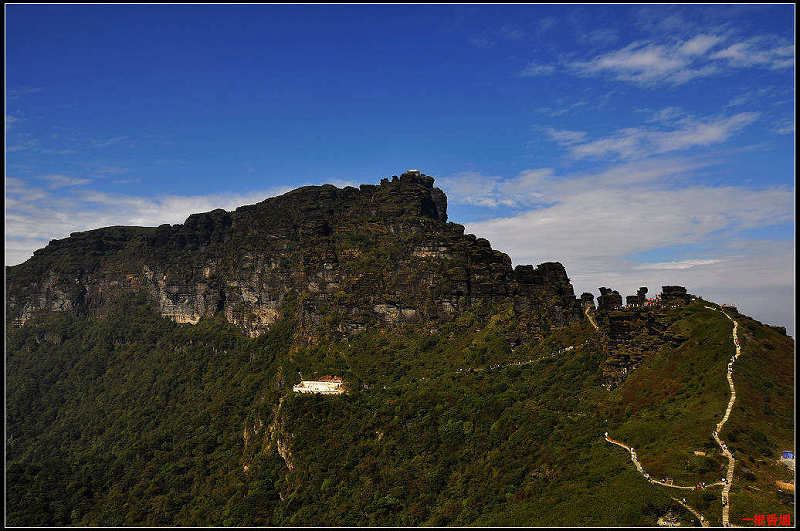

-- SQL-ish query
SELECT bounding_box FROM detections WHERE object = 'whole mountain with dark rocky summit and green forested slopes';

[6,172,795,526]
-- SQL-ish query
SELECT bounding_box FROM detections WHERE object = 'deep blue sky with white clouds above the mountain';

[5,5,795,330]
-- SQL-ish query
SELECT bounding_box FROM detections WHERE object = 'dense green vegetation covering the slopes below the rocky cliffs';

[6,298,794,525]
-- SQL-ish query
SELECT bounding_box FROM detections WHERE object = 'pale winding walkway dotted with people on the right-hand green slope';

[608,306,741,527]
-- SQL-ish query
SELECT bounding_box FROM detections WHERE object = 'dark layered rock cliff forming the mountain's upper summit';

[7,173,581,338]
